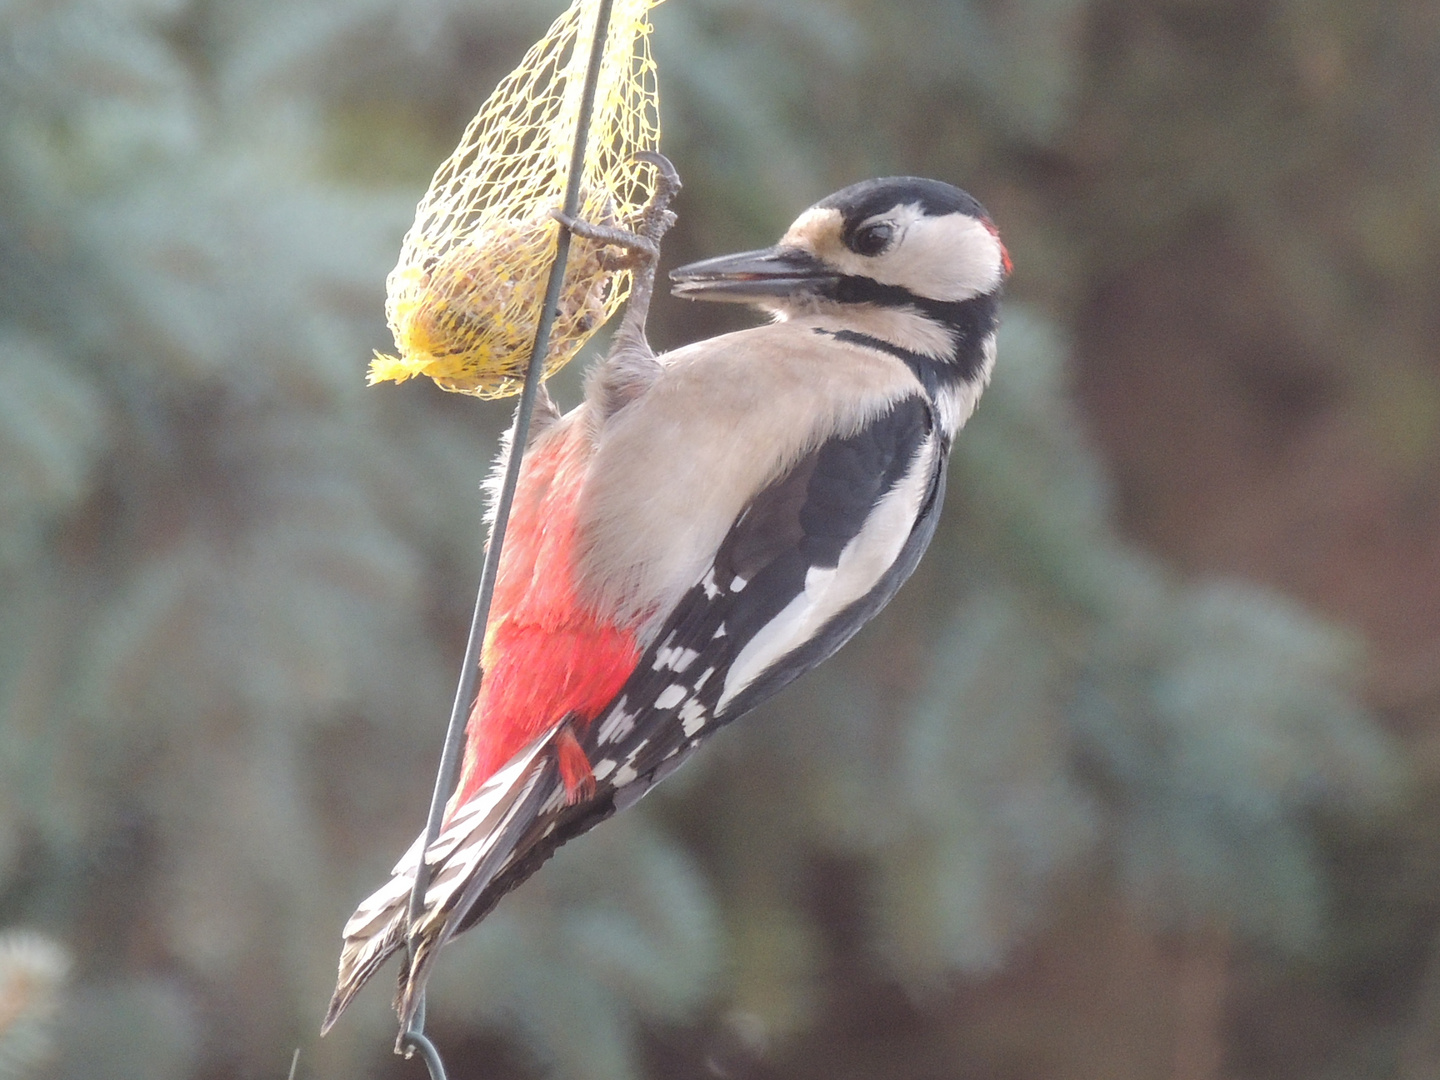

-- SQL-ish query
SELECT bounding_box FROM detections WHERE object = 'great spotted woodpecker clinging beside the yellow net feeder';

[324,163,1009,1028]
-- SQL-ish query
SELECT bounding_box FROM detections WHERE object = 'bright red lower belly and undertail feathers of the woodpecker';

[452,425,639,806]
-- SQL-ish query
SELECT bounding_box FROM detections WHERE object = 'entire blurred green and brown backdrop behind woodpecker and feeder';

[0,0,1440,1080]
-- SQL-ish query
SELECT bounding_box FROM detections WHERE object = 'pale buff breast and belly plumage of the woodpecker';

[577,324,917,633]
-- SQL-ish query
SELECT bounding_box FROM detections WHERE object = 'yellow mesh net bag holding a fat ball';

[369,0,661,397]
